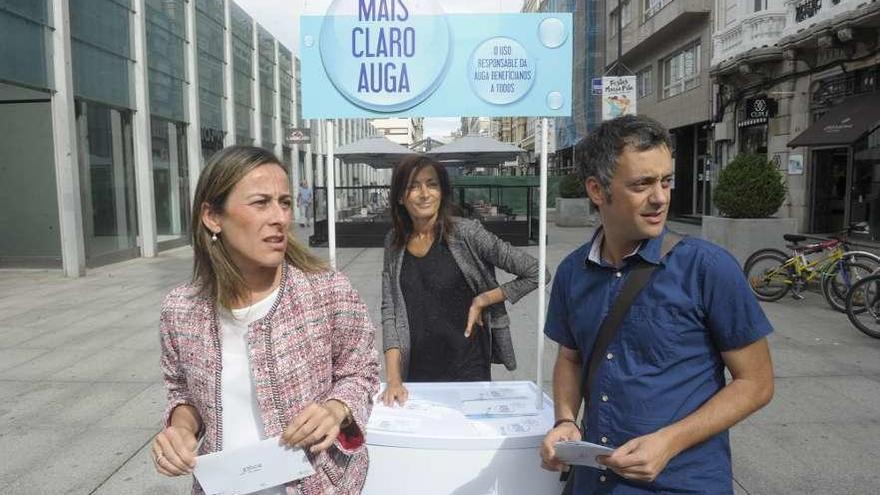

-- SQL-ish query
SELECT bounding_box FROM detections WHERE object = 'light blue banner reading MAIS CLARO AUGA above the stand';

[300,0,572,119]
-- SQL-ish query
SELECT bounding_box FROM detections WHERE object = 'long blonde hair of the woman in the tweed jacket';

[191,146,327,308]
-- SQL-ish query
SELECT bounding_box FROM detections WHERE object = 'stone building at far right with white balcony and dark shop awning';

[712,0,880,241]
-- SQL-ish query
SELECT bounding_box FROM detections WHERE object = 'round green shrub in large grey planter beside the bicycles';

[702,154,798,263]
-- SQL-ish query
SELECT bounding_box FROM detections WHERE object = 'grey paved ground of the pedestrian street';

[0,224,880,495]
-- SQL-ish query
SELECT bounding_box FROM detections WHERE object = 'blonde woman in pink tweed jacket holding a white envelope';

[151,146,378,495]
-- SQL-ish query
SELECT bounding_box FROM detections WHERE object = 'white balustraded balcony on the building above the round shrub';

[712,10,788,67]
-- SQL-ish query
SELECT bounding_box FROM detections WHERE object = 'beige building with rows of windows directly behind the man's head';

[605,0,713,221]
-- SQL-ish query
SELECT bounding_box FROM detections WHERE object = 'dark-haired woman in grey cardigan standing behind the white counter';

[381,155,550,405]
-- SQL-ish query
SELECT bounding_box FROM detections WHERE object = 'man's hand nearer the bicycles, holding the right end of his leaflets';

[598,430,677,482]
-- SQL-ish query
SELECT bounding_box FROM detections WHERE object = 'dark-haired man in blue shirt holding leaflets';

[541,116,773,495]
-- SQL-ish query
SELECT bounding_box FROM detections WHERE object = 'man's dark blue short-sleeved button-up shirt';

[544,230,772,495]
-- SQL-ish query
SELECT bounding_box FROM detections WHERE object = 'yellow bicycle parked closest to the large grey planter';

[743,222,880,312]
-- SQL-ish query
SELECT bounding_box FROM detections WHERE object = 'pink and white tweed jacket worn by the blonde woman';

[160,264,379,495]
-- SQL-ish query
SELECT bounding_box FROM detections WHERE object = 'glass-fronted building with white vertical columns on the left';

[0,0,371,276]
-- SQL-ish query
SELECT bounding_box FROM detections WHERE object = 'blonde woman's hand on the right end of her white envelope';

[281,399,349,454]
